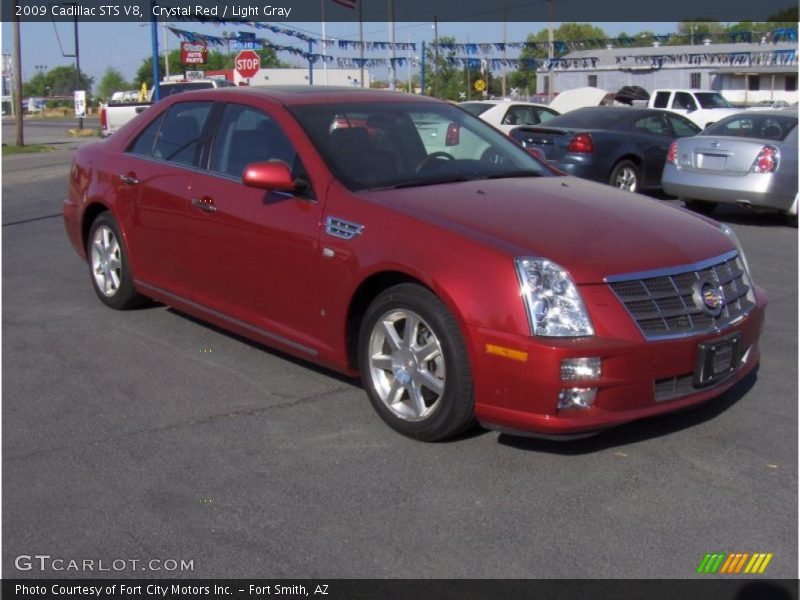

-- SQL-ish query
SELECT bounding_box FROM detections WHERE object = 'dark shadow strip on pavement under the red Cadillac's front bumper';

[497,367,758,455]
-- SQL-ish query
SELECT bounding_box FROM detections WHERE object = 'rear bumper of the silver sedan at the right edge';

[661,163,796,211]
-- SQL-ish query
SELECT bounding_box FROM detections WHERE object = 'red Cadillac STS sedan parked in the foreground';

[64,87,766,441]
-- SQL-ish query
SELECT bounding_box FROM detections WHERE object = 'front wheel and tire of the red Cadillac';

[358,283,476,442]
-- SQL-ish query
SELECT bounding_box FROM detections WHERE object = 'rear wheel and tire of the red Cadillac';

[86,212,145,310]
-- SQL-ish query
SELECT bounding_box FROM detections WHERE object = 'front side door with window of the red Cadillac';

[191,104,322,347]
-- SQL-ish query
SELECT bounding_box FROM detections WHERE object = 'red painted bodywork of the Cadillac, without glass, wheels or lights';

[64,88,766,434]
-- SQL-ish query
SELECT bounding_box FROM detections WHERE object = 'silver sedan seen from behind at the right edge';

[661,110,797,223]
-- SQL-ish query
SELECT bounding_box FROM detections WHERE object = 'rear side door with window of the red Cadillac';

[118,102,212,298]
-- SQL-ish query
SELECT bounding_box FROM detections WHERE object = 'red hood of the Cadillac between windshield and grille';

[361,177,734,284]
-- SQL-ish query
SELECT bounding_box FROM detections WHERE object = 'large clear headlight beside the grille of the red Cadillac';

[516,257,594,337]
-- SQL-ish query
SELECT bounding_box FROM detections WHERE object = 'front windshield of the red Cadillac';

[292,102,552,191]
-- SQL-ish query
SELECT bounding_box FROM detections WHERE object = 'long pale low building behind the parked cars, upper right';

[536,41,797,104]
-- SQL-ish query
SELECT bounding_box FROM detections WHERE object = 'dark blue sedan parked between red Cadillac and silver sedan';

[511,106,700,192]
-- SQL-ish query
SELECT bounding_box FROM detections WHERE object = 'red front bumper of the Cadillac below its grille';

[469,287,766,437]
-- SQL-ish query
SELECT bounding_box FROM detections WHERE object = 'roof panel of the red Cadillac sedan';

[187,85,441,105]
